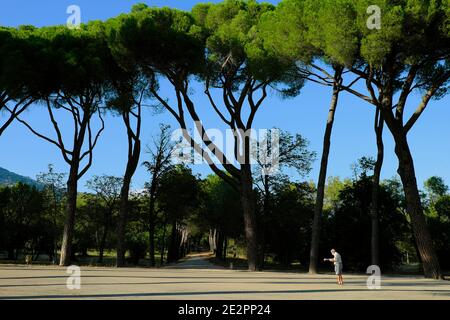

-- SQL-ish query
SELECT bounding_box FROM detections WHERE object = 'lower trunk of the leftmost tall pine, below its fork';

[59,162,79,266]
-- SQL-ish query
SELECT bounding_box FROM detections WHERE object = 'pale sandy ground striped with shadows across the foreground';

[0,255,450,300]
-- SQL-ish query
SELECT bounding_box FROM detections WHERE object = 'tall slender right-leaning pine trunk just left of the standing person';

[309,68,342,274]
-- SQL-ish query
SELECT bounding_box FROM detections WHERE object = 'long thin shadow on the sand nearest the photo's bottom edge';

[0,289,450,300]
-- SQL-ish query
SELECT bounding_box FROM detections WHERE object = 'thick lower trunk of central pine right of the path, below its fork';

[241,164,258,271]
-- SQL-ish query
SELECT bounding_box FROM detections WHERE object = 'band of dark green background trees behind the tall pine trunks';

[0,167,450,272]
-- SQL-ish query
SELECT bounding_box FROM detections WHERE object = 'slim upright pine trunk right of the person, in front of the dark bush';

[370,109,384,266]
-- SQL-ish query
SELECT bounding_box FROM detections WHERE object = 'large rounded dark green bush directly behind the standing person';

[323,177,415,271]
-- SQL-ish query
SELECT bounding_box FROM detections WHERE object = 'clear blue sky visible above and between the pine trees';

[0,0,450,190]
